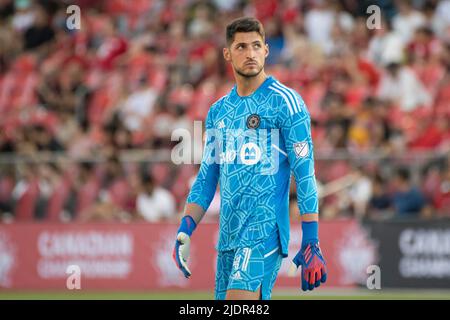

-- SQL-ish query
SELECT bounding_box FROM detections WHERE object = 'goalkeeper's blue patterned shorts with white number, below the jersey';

[215,230,283,300]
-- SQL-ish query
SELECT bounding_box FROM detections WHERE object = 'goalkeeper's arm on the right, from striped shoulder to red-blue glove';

[279,89,327,291]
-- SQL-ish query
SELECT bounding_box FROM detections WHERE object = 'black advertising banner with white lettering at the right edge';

[365,220,450,288]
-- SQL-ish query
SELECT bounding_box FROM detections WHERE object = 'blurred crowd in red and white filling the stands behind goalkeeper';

[0,0,450,222]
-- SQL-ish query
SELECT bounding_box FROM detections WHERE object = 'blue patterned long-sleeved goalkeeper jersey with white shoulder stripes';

[186,76,318,256]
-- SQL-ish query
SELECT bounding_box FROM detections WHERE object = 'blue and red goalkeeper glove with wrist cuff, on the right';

[289,221,327,291]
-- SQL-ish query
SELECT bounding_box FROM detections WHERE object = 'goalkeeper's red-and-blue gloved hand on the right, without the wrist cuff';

[289,242,327,291]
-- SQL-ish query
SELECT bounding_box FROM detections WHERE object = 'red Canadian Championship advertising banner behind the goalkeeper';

[0,220,372,290]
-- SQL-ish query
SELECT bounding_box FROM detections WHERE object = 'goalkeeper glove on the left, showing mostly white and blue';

[172,215,197,278]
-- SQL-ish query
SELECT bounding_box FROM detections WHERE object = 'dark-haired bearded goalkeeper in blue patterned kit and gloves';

[173,18,327,300]
